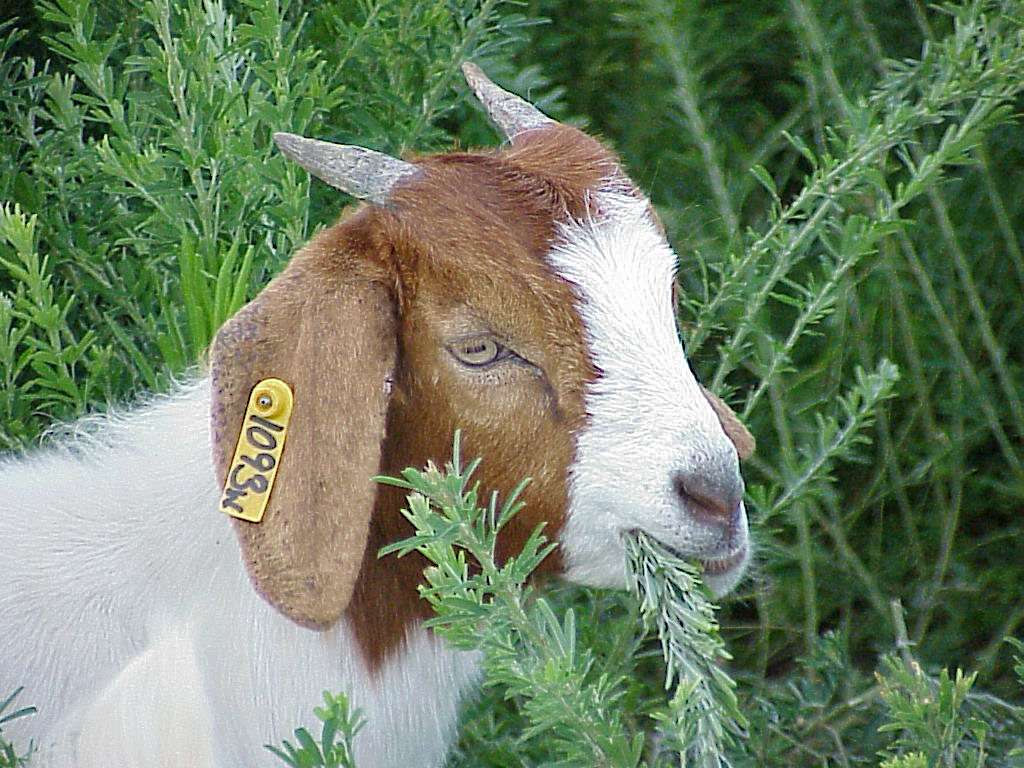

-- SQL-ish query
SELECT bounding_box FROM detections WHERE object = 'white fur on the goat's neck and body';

[0,381,478,768]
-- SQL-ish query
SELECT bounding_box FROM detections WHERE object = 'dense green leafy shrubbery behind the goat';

[0,0,1024,765]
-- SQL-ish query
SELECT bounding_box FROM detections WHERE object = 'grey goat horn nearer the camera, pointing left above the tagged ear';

[273,133,422,203]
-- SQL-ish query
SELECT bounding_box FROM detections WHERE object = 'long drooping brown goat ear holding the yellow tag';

[210,240,396,629]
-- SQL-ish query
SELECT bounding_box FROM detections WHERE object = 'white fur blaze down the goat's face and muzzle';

[549,191,748,594]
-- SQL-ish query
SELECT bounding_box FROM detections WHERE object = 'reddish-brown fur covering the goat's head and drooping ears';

[212,124,753,668]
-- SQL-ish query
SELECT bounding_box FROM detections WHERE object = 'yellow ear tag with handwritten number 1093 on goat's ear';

[220,379,292,522]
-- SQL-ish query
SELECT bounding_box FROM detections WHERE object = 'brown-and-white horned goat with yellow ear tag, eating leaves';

[0,63,753,768]
